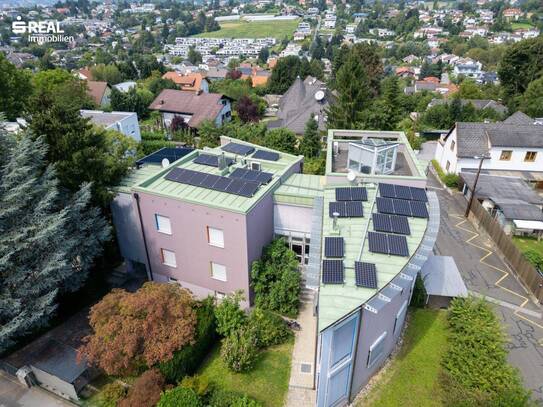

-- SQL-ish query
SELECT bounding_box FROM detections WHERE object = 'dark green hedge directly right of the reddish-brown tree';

[158,297,217,384]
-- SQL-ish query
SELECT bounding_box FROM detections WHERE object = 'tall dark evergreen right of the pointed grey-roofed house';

[328,55,371,129]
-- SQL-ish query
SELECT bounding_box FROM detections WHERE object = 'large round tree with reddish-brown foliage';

[79,282,197,374]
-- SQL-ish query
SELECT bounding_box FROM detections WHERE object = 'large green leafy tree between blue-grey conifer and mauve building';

[29,91,136,205]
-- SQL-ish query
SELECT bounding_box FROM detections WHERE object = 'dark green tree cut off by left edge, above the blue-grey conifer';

[0,53,32,120]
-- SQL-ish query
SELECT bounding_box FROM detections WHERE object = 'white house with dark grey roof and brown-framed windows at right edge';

[435,112,543,181]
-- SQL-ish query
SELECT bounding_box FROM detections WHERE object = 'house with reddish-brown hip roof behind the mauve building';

[149,89,232,129]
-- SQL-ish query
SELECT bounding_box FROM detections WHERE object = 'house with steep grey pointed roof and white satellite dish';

[268,76,336,134]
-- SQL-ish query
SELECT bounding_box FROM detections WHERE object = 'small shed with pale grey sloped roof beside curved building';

[420,256,468,308]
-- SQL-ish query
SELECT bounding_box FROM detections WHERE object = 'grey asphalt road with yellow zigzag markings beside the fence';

[428,173,543,404]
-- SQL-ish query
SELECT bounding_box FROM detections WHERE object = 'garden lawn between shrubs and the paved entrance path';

[198,339,294,407]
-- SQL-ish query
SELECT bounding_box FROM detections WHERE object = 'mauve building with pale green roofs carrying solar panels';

[113,130,439,407]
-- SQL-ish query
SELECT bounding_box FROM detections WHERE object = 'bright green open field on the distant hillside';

[195,19,298,40]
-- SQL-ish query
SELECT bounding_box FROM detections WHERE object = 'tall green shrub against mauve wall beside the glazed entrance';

[251,239,300,316]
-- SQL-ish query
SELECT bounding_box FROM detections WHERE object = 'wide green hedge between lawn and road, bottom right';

[442,297,530,406]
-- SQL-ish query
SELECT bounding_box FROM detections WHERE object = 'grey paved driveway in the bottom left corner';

[0,372,75,407]
